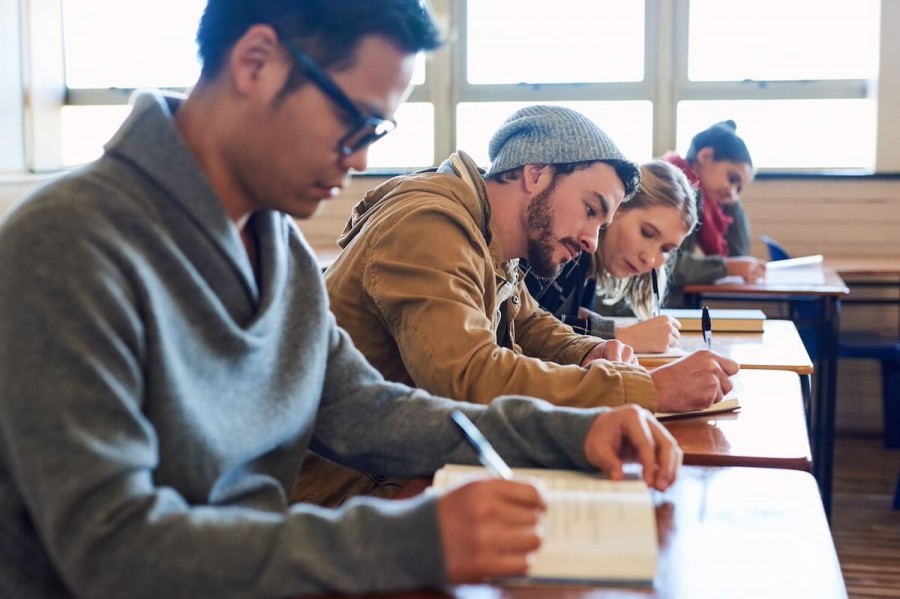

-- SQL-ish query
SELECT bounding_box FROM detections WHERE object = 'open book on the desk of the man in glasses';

[432,464,658,584]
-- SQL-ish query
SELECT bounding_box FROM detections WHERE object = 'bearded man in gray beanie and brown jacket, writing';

[295,106,737,505]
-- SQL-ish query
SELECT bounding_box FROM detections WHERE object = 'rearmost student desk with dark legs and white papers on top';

[684,265,849,514]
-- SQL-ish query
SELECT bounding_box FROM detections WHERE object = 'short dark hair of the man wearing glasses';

[197,0,441,82]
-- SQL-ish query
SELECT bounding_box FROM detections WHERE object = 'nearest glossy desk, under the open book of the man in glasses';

[312,466,847,599]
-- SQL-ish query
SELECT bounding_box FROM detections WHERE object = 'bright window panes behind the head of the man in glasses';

[51,0,434,169]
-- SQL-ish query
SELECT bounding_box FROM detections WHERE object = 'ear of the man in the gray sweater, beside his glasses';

[228,25,290,95]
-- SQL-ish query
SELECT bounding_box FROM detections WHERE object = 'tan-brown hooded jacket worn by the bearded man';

[325,153,656,410]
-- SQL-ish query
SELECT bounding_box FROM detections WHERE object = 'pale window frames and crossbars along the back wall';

[10,0,900,174]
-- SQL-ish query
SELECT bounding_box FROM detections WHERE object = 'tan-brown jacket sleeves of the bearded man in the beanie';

[363,202,656,409]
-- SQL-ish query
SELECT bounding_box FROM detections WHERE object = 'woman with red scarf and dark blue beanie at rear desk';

[663,120,766,287]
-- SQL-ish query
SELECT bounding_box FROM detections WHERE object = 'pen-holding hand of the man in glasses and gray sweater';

[437,478,547,584]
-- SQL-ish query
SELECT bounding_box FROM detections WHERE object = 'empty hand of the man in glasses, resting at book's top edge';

[584,404,683,491]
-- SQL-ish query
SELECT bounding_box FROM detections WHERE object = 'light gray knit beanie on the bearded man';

[485,104,641,201]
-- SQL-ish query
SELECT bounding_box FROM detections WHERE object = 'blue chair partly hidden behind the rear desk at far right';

[760,235,900,448]
